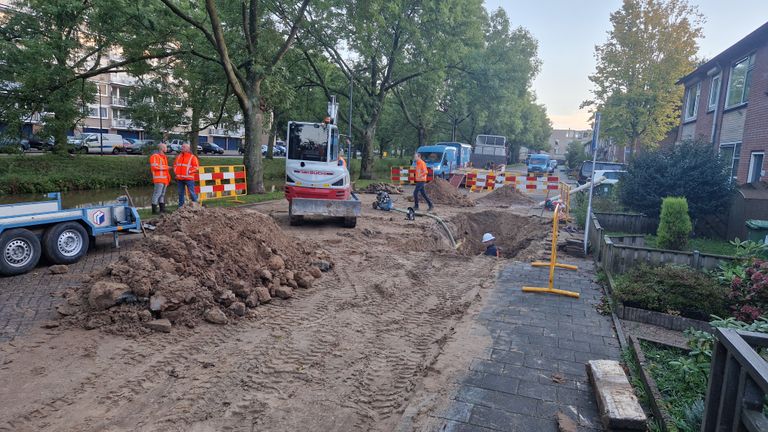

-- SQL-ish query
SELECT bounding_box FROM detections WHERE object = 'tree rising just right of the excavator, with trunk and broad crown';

[312,0,484,178]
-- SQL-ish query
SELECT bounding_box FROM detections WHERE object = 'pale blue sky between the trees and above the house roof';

[485,0,768,129]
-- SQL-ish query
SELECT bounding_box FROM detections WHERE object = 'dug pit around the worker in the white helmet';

[450,210,552,260]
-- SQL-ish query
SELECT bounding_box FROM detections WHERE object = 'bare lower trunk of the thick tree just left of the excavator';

[243,80,264,194]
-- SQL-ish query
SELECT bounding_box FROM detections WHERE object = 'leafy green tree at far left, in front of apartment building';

[0,0,183,151]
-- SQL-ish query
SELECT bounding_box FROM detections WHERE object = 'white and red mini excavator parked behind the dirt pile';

[285,96,360,228]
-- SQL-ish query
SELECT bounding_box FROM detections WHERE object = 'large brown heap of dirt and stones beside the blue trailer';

[58,206,333,335]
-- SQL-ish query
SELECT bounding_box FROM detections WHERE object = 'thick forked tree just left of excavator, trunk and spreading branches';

[161,0,310,193]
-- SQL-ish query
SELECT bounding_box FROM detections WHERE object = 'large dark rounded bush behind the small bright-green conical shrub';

[620,141,734,220]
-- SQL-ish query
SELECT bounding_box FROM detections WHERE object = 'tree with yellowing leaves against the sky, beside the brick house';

[582,0,704,153]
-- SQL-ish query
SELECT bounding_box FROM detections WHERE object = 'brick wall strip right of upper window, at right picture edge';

[738,41,768,184]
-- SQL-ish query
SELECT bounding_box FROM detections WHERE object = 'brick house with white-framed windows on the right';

[677,23,768,185]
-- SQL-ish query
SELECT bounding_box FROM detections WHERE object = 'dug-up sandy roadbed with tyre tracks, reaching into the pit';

[0,197,547,431]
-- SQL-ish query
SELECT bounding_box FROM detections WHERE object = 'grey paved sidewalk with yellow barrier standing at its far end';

[431,260,620,432]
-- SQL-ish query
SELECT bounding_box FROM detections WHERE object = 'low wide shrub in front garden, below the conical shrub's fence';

[614,264,728,319]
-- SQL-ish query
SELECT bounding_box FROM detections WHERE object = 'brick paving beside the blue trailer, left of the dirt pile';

[0,235,138,342]
